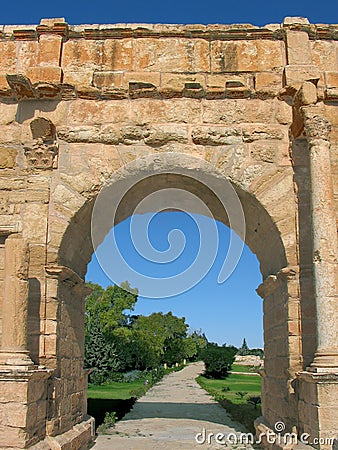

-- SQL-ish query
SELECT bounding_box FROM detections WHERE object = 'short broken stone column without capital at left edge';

[0,234,33,368]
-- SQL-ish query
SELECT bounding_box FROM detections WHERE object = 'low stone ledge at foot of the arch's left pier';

[28,416,95,450]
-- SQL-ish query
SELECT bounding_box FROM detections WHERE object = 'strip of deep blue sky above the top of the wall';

[0,0,338,25]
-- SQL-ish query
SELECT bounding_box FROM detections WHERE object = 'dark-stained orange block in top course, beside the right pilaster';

[210,40,284,73]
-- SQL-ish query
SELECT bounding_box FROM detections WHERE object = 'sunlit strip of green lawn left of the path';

[87,381,144,400]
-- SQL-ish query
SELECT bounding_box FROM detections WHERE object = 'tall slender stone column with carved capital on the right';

[302,106,338,372]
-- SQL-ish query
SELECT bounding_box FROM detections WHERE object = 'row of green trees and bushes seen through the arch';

[85,281,264,384]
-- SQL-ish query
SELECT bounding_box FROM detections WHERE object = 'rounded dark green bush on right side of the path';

[201,343,237,378]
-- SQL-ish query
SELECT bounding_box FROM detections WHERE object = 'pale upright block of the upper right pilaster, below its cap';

[286,30,312,65]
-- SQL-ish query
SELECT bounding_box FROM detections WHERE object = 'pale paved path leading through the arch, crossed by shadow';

[93,363,252,450]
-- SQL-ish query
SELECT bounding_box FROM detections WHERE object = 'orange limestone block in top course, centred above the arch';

[135,38,210,72]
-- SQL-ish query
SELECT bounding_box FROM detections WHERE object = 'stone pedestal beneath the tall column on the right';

[297,371,338,450]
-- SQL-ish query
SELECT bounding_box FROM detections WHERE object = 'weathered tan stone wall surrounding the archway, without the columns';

[0,18,338,448]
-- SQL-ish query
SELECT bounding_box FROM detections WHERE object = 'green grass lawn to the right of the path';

[197,366,261,433]
